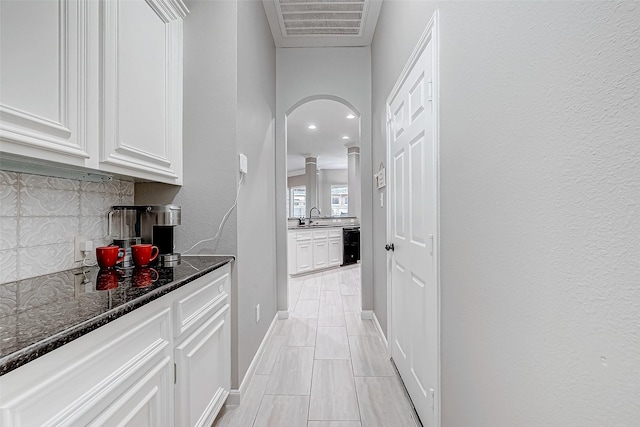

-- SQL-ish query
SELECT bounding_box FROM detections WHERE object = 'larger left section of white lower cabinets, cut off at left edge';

[0,304,173,427]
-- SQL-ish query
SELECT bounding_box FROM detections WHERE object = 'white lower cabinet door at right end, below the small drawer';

[175,304,231,427]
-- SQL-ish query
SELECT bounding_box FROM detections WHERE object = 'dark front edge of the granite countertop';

[0,256,235,376]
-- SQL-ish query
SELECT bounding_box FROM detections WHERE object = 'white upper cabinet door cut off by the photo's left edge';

[0,0,90,166]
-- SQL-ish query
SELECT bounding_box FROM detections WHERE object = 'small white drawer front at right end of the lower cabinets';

[173,268,229,337]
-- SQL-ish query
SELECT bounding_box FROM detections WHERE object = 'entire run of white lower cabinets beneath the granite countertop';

[0,264,231,427]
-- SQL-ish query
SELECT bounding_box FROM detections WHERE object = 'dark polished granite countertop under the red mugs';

[0,256,234,375]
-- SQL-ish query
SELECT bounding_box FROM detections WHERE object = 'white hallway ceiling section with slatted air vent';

[262,0,382,47]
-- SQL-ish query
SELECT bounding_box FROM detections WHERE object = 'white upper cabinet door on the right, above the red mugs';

[100,0,186,184]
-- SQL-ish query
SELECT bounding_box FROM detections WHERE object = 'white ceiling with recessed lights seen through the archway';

[287,99,360,175]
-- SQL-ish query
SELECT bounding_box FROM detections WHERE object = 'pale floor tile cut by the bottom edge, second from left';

[252,395,309,427]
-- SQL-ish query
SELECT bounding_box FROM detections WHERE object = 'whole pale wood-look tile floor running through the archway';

[214,265,420,427]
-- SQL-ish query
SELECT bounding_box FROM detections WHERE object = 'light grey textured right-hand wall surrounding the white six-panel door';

[372,1,640,427]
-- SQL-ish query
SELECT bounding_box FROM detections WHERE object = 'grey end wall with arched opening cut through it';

[276,47,373,310]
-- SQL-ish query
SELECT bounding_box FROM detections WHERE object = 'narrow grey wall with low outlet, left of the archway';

[236,1,277,390]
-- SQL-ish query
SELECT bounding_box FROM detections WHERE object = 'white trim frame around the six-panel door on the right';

[385,10,442,427]
